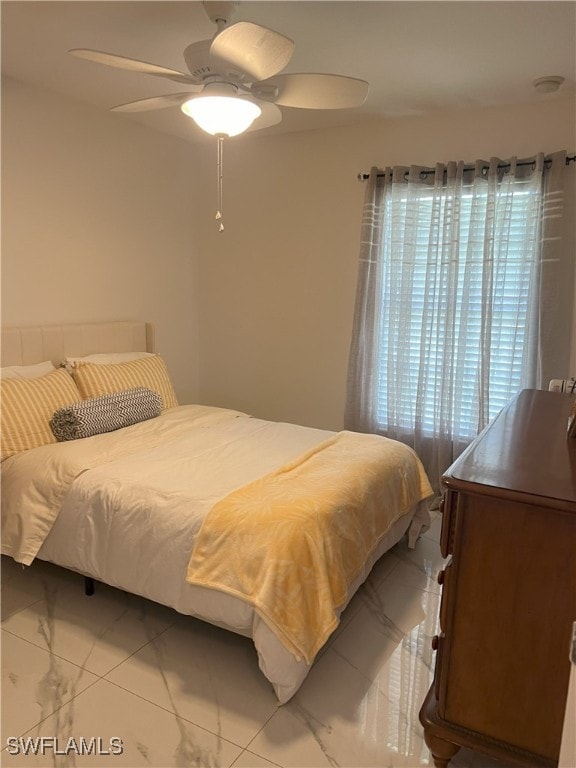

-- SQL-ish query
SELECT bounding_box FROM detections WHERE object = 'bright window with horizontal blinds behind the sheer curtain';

[376,181,540,442]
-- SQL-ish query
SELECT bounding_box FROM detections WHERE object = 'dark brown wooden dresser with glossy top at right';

[420,390,576,768]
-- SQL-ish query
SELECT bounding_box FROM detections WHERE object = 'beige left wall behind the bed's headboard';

[2,79,199,401]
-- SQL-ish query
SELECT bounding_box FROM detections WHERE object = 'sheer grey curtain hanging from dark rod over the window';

[345,152,574,489]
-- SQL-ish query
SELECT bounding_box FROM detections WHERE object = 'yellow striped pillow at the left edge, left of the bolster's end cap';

[0,369,81,460]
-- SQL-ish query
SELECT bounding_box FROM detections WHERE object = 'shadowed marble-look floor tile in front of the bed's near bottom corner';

[107,617,277,747]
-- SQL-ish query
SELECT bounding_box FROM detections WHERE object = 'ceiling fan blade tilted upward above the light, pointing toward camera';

[210,21,294,80]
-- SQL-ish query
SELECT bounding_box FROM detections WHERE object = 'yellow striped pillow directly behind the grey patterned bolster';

[72,355,178,409]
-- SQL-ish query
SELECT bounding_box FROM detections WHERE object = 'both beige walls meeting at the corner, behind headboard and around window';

[2,81,576,429]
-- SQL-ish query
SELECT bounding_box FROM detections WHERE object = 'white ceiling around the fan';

[1,0,576,141]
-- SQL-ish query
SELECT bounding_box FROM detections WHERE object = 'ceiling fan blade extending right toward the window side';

[252,73,368,109]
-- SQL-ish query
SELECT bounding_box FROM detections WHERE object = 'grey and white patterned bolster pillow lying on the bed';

[50,387,162,441]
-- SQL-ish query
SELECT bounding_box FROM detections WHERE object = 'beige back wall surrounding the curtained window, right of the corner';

[195,100,576,429]
